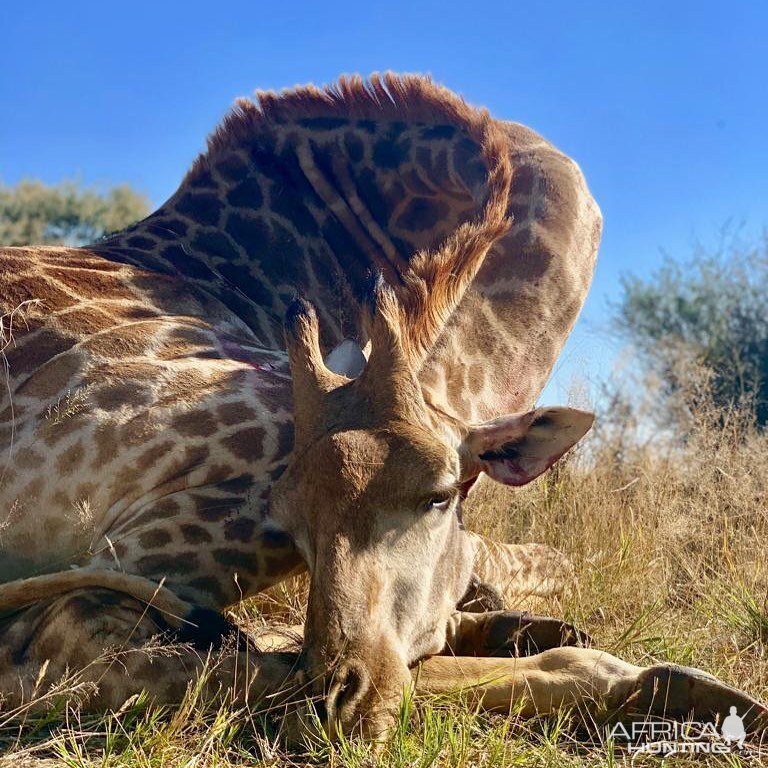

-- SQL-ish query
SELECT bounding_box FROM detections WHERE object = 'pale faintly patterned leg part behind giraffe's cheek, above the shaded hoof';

[467,532,573,597]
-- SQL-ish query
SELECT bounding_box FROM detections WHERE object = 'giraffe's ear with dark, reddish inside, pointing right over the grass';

[460,407,595,485]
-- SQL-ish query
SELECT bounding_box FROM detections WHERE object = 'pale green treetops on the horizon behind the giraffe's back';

[0,180,149,245]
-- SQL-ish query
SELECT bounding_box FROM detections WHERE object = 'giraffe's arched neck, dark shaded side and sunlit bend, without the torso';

[93,76,601,422]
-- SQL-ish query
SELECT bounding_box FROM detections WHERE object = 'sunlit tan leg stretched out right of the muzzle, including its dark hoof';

[413,647,768,733]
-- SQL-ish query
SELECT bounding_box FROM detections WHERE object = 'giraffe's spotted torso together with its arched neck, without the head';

[0,78,600,608]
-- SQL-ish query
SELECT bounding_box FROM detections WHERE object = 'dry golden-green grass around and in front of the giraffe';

[0,392,768,768]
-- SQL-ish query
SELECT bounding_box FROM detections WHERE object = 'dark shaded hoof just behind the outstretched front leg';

[484,611,592,656]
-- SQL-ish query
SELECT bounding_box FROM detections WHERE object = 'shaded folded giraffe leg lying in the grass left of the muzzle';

[0,589,298,722]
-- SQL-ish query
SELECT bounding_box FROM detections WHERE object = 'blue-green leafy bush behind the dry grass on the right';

[614,234,768,426]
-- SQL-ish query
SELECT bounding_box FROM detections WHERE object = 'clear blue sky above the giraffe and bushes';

[0,0,768,402]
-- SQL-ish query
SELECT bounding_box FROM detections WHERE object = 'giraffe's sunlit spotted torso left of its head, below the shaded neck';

[0,249,297,608]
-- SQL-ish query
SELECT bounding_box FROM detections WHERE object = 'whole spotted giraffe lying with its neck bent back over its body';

[0,76,765,736]
